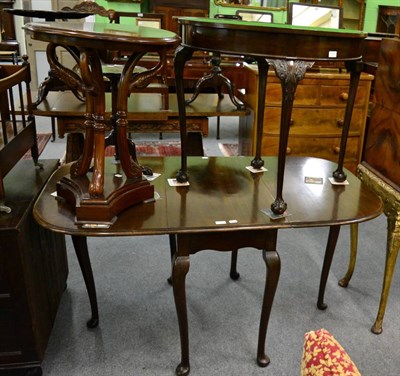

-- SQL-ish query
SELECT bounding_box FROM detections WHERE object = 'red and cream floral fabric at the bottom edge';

[301,329,361,376]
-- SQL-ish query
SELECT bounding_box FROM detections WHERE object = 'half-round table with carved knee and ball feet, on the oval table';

[174,17,366,214]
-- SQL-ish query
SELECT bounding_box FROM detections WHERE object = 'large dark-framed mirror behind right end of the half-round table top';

[287,3,343,29]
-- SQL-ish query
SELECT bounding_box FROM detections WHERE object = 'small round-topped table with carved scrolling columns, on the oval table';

[24,22,180,223]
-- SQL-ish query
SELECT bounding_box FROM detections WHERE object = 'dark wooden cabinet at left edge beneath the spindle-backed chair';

[0,160,68,375]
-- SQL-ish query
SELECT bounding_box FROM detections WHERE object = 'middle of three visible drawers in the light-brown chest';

[264,107,365,137]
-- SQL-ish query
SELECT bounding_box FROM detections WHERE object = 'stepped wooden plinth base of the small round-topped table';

[57,169,154,225]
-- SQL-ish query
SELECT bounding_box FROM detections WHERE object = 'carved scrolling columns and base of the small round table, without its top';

[47,43,154,223]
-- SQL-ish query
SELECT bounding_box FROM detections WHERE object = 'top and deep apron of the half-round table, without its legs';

[178,17,366,61]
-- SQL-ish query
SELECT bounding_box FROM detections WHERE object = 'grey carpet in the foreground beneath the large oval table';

[43,216,400,376]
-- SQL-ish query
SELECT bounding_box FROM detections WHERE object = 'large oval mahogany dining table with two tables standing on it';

[33,157,382,375]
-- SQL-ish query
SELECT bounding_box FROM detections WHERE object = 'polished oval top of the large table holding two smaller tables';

[34,157,383,236]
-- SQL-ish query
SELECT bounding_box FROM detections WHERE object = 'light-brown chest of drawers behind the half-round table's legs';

[239,66,373,172]
